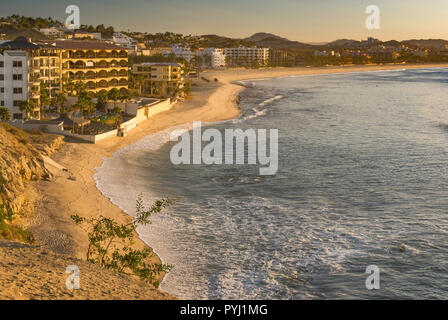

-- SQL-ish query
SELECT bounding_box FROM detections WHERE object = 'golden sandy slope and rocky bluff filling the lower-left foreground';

[0,122,173,300]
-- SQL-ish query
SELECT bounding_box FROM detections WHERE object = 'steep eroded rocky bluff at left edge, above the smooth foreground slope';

[0,123,63,242]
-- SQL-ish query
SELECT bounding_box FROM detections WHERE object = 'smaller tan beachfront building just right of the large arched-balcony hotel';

[132,62,184,97]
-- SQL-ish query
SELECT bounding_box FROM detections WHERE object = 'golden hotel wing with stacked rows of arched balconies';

[39,40,128,92]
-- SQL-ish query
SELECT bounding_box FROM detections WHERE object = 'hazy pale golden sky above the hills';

[0,0,448,42]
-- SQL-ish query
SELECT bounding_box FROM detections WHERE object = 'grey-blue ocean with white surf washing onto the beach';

[95,68,448,299]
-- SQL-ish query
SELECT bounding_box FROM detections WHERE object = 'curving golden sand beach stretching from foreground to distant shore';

[30,64,448,298]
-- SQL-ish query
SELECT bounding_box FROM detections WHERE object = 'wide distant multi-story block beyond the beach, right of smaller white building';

[224,47,269,67]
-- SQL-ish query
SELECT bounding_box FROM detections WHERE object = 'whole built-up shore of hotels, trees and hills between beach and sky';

[0,15,448,135]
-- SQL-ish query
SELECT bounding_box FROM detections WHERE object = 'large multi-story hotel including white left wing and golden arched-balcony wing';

[0,37,129,119]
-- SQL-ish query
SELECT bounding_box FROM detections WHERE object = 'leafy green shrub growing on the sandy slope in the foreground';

[71,196,175,286]
